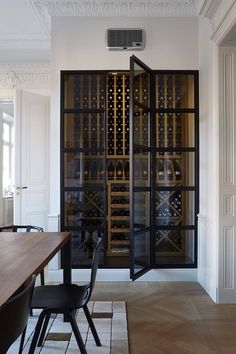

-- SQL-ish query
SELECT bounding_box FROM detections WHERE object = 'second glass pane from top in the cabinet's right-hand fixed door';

[156,113,195,148]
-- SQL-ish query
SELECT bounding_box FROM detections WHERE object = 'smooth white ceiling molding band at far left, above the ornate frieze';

[0,35,50,49]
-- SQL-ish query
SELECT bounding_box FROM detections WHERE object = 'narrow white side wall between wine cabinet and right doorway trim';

[198,18,219,301]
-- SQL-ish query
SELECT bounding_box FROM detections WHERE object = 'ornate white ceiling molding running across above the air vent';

[30,0,198,33]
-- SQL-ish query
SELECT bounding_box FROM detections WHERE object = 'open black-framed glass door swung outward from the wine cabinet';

[130,56,151,280]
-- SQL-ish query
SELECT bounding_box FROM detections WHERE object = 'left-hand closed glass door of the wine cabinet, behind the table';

[61,71,106,268]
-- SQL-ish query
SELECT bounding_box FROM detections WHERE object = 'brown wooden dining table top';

[0,232,71,306]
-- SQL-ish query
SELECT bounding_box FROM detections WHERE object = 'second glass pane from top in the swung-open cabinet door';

[133,106,150,146]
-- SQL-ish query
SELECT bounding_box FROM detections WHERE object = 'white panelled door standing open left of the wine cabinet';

[14,90,49,230]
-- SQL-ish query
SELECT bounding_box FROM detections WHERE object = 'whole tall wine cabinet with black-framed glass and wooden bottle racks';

[61,60,199,270]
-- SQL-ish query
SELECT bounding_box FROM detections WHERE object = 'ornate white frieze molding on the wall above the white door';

[0,63,50,89]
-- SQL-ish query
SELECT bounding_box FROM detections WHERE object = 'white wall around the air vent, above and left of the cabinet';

[50,17,198,216]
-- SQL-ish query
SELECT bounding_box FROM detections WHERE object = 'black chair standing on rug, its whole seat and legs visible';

[29,238,102,354]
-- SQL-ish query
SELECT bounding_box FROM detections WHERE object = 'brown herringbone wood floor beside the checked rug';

[93,282,236,354]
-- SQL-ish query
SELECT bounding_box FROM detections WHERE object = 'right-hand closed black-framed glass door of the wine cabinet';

[153,72,199,268]
